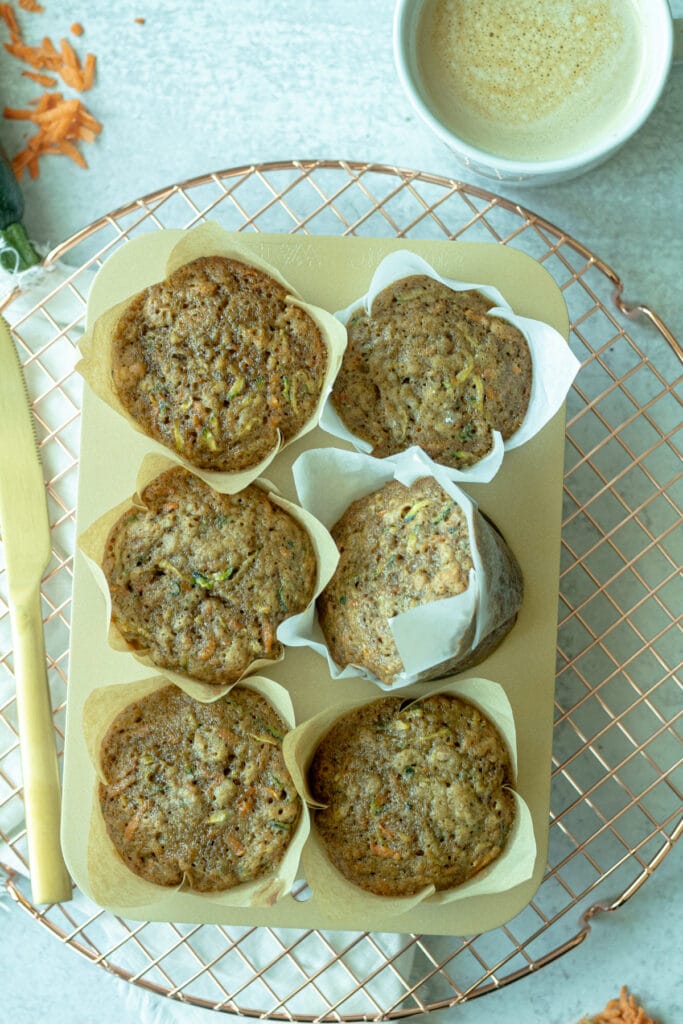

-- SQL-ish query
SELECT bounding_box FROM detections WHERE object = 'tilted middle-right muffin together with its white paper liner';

[282,449,523,689]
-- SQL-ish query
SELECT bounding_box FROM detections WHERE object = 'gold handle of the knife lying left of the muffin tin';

[9,588,72,903]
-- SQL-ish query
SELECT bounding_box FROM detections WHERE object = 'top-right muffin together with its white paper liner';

[321,250,580,482]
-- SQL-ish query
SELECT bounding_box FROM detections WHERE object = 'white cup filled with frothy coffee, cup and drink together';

[394,0,673,183]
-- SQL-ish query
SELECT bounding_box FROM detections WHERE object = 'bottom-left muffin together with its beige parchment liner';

[83,676,309,907]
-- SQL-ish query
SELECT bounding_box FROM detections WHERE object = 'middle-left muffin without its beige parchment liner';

[102,467,316,685]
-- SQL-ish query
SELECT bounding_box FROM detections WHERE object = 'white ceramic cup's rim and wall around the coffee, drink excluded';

[393,0,683,185]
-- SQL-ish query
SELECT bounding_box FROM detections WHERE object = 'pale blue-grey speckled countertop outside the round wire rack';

[0,0,683,1024]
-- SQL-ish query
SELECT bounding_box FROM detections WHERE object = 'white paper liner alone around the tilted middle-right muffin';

[282,447,519,690]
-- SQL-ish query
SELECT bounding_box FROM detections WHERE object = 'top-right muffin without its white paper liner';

[332,274,531,469]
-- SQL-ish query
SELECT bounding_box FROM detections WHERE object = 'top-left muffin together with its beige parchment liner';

[77,222,346,493]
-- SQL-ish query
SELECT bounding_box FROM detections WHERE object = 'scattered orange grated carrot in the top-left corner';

[0,0,102,178]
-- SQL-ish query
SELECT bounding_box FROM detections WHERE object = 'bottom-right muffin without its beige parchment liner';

[307,694,515,896]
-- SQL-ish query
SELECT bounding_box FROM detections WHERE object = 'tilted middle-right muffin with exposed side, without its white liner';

[317,477,522,684]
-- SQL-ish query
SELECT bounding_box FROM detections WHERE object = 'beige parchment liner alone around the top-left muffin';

[76,221,346,494]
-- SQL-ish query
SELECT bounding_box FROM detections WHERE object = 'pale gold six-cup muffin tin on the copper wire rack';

[62,230,567,935]
